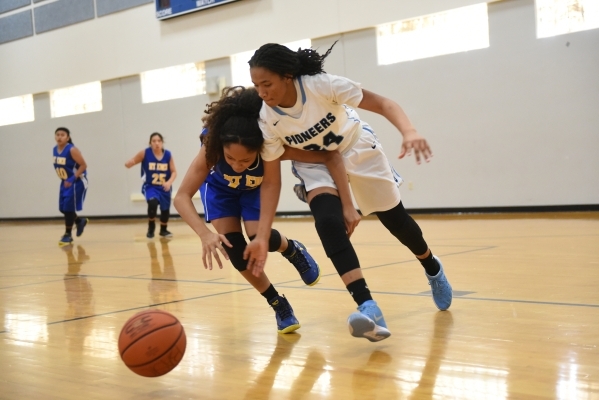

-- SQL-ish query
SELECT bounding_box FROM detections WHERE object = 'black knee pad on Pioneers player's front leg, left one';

[310,193,351,257]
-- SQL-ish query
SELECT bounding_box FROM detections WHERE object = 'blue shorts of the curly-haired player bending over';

[200,182,260,222]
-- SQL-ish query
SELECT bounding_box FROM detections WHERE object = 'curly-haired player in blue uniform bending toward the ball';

[174,86,355,333]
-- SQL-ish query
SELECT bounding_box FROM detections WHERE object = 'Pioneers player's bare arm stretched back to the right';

[358,89,433,164]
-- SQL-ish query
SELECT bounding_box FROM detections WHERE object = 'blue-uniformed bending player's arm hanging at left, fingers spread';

[174,147,232,269]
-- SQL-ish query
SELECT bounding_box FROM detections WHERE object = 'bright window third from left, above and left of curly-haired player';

[140,63,206,103]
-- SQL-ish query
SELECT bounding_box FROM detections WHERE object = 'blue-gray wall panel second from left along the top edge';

[34,0,95,33]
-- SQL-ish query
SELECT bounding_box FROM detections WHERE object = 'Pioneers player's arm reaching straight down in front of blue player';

[243,158,281,276]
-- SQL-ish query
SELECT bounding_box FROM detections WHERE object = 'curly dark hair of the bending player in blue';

[201,86,264,169]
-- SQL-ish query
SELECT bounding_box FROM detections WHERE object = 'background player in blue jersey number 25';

[125,132,177,239]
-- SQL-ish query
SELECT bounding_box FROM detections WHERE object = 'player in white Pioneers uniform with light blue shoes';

[245,43,452,342]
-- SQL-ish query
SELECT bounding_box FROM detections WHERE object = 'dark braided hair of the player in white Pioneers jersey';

[249,41,337,78]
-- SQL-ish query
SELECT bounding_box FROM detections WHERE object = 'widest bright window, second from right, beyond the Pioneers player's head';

[377,3,489,65]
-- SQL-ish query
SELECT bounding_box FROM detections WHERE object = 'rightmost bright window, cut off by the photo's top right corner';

[536,0,599,38]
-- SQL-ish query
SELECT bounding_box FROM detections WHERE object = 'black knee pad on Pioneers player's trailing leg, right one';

[376,202,428,255]
